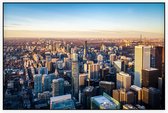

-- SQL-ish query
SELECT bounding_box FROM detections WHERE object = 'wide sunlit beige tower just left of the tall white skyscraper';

[117,72,131,91]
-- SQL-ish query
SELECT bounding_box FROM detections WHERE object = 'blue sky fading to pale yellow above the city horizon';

[4,3,164,38]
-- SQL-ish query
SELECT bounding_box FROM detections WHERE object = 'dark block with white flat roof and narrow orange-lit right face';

[130,85,142,104]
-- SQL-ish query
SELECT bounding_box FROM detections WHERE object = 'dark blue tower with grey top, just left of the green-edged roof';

[82,86,94,109]
